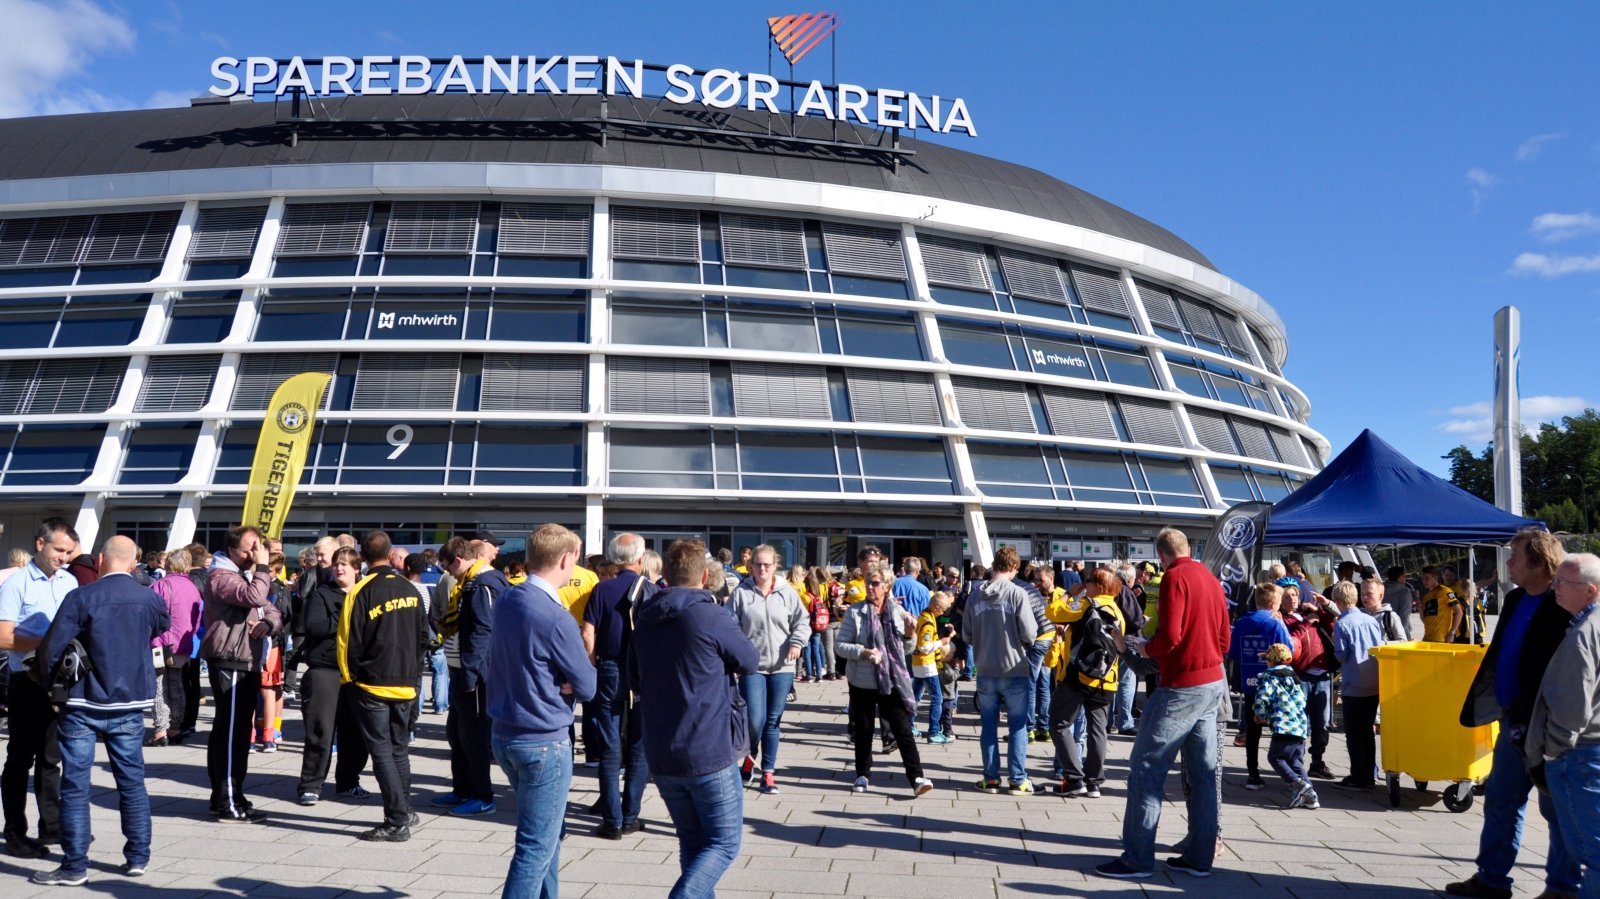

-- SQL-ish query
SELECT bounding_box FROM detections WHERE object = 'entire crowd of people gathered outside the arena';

[0,520,1600,899]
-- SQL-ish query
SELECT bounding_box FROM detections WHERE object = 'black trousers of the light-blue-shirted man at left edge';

[0,672,61,837]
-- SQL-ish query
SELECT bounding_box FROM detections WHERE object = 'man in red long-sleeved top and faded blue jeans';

[1094,528,1232,880]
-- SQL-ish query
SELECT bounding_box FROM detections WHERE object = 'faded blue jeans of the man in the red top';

[1122,678,1227,872]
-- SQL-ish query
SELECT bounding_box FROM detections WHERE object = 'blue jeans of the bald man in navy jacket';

[59,709,150,873]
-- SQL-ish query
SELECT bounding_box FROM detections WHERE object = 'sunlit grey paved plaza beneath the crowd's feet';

[0,681,1547,899]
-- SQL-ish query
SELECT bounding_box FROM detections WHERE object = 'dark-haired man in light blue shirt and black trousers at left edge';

[0,518,78,859]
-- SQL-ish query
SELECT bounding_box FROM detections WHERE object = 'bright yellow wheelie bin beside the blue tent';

[1373,641,1499,811]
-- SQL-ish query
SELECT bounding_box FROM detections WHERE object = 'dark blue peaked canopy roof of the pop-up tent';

[1264,430,1539,545]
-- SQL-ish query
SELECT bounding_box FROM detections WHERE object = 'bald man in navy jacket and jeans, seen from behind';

[34,537,171,886]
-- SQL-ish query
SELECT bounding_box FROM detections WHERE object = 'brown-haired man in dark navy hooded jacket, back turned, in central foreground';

[630,541,760,899]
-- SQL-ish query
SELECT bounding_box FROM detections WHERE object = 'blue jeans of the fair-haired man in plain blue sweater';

[490,734,573,899]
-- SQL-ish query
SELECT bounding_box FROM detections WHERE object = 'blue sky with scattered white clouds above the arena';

[0,0,1600,472]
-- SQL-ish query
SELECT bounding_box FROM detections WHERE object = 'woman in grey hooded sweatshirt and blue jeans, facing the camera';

[728,544,811,793]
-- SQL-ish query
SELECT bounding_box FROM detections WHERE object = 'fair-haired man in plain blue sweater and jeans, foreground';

[485,525,595,899]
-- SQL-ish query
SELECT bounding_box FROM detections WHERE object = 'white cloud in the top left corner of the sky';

[0,0,134,118]
